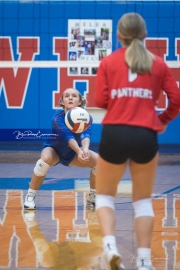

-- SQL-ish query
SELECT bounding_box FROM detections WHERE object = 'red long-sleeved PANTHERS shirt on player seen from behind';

[95,48,180,131]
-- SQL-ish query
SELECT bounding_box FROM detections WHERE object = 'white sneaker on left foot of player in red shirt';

[104,244,125,270]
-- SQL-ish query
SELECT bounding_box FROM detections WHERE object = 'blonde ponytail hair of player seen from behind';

[117,13,154,74]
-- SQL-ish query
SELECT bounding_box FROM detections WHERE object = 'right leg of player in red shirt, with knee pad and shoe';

[130,154,158,270]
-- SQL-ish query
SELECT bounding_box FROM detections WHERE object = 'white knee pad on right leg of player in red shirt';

[133,198,154,218]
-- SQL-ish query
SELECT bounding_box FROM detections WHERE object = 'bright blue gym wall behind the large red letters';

[0,1,180,144]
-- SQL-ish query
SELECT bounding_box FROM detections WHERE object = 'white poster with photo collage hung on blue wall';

[68,20,112,76]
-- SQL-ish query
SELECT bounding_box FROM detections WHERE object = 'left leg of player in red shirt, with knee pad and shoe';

[96,157,126,270]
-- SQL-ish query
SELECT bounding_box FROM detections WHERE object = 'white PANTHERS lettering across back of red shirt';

[111,87,152,99]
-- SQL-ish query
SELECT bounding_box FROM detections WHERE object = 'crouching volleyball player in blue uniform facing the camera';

[24,88,98,209]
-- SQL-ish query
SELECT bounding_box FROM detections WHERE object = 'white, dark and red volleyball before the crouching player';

[65,107,91,133]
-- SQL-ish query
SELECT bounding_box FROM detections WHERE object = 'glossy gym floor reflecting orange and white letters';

[0,155,180,270]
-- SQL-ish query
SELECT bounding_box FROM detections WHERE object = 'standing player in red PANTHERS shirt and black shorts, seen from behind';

[95,13,180,270]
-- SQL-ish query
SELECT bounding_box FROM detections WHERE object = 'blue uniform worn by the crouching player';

[43,109,92,166]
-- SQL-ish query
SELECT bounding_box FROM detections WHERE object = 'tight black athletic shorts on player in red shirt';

[99,125,158,164]
